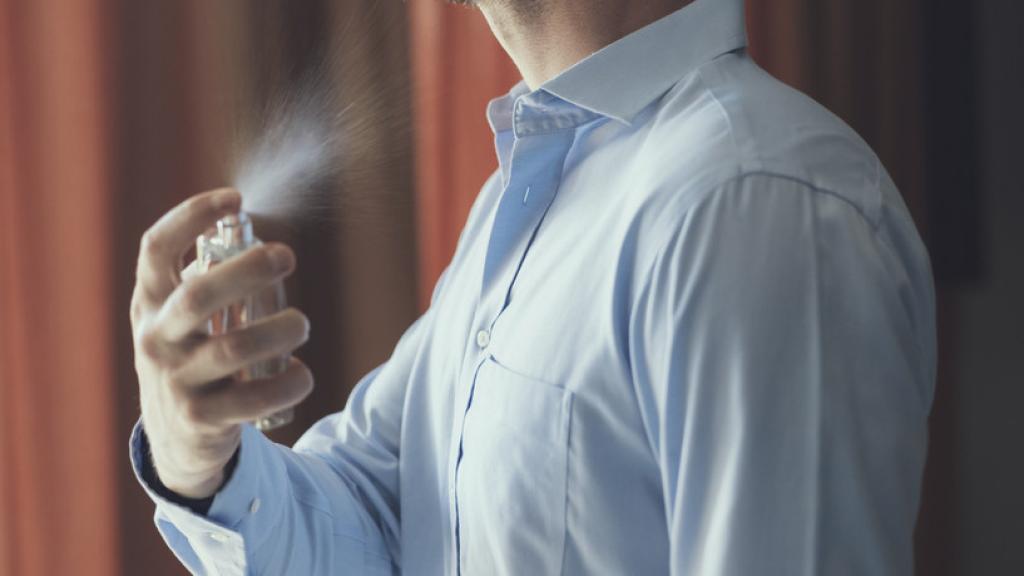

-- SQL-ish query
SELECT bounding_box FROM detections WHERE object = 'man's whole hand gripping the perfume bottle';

[131,189,313,498]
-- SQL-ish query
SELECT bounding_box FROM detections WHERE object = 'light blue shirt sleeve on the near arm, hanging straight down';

[630,175,934,576]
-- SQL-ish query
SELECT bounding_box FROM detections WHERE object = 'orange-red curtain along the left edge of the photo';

[0,0,117,576]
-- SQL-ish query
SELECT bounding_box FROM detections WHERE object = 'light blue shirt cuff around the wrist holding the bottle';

[129,420,287,574]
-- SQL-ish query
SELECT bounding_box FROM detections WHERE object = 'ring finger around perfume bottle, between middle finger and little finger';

[174,308,309,386]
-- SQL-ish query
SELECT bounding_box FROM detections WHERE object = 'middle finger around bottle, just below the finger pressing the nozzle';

[158,244,295,341]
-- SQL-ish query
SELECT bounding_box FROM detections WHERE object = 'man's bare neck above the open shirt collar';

[479,0,693,89]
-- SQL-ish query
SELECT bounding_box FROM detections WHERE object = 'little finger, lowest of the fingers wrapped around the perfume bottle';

[189,358,313,425]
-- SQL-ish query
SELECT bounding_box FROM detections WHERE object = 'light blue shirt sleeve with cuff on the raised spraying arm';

[130,303,430,575]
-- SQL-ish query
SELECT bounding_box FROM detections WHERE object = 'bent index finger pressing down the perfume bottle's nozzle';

[138,188,242,300]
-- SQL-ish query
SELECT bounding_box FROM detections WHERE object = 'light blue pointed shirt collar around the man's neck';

[487,0,746,132]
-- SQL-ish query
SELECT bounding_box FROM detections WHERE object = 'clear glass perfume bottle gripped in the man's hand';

[196,212,294,430]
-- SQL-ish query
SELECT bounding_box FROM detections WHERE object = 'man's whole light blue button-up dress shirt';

[132,0,935,576]
